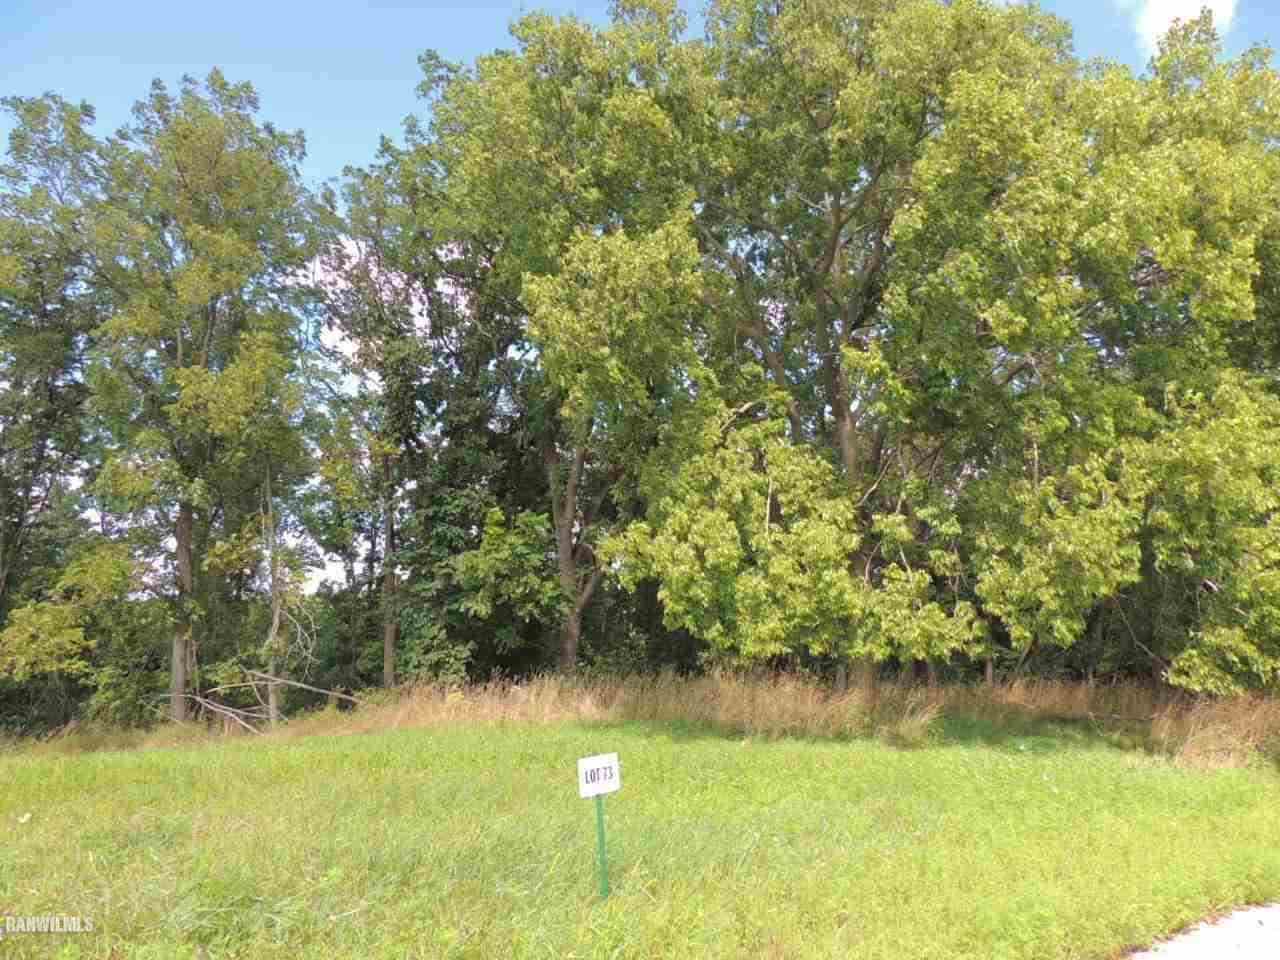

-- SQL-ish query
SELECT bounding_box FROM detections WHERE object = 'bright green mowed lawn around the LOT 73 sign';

[0,724,1280,960]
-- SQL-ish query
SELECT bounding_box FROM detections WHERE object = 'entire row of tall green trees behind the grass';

[0,0,1280,728]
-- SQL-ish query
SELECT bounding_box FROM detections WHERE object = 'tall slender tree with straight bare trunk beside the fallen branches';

[91,70,314,719]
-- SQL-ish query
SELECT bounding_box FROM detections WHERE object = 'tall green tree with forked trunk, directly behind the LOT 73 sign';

[420,4,696,671]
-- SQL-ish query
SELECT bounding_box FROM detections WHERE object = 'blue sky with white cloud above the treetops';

[0,0,1280,183]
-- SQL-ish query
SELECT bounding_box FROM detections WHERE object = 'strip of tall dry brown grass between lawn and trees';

[17,672,1280,767]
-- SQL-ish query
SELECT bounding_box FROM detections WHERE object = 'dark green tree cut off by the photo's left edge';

[0,96,104,622]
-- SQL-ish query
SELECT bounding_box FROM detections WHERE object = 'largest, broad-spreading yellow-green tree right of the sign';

[601,0,1276,701]
